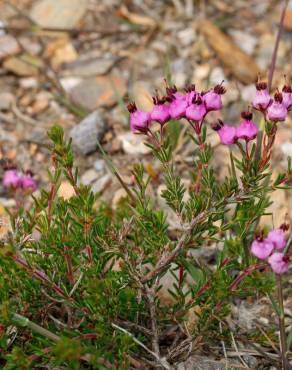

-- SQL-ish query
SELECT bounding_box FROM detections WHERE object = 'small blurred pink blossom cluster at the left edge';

[3,169,37,192]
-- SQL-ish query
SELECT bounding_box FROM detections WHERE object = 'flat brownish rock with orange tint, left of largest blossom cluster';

[71,76,126,110]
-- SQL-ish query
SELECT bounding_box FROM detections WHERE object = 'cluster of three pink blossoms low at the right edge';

[251,224,289,274]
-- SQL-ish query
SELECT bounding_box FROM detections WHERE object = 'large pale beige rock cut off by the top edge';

[30,0,88,29]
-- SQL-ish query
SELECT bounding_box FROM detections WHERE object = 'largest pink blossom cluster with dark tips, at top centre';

[128,84,225,134]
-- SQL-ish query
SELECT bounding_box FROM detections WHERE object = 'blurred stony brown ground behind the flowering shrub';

[0,0,292,368]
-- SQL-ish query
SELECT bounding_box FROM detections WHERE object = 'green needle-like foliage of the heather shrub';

[0,118,291,369]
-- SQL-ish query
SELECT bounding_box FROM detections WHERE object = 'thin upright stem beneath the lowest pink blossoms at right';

[276,274,290,370]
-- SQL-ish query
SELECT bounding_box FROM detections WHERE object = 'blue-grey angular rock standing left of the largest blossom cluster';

[70,110,106,155]
